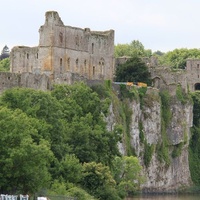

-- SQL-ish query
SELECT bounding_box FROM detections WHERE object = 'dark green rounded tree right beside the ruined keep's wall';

[115,56,151,85]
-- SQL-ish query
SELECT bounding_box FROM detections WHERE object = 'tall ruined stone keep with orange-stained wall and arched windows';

[10,11,114,83]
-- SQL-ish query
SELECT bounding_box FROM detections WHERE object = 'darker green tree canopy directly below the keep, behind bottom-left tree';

[0,83,120,165]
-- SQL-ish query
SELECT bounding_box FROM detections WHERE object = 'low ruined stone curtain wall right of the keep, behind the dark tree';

[115,56,200,95]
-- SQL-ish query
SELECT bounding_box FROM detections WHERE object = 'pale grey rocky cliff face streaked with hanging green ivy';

[107,85,193,193]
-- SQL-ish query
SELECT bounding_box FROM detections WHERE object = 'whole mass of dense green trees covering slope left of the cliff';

[0,83,144,200]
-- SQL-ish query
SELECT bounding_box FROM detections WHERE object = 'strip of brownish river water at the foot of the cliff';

[126,194,200,200]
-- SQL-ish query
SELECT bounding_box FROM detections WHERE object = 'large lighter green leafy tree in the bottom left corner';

[0,107,53,194]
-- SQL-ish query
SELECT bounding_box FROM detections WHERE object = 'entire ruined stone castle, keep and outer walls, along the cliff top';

[0,11,200,93]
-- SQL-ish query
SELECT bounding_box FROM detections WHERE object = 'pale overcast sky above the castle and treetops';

[0,0,200,52]
